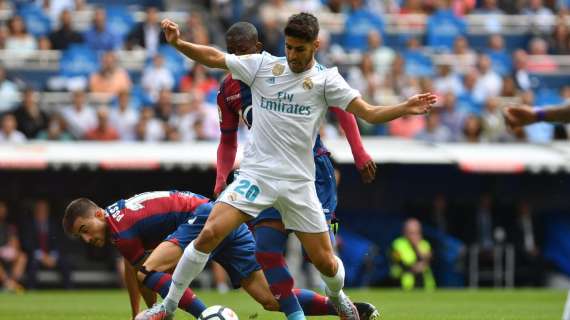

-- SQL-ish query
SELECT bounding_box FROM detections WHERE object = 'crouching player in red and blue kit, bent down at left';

[62,191,369,318]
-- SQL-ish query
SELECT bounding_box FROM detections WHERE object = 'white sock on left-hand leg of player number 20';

[163,241,210,313]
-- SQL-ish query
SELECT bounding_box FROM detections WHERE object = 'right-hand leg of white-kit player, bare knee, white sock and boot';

[295,231,359,320]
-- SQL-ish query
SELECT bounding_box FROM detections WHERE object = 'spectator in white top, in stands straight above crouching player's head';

[61,91,97,139]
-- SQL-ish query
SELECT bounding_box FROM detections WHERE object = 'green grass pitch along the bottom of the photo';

[0,289,566,320]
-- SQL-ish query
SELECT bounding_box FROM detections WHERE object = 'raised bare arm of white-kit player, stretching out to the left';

[160,19,228,70]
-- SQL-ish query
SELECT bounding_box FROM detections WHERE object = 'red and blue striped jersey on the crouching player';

[105,191,210,265]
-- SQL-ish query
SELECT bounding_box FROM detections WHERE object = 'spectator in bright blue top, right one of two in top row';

[426,0,467,51]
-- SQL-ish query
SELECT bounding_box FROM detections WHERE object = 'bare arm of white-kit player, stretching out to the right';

[346,93,437,124]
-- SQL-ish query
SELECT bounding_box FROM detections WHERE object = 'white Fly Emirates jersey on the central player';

[226,52,360,180]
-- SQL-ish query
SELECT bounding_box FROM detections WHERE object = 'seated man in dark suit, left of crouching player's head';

[22,200,72,289]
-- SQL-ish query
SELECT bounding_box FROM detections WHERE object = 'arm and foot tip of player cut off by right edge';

[504,104,570,320]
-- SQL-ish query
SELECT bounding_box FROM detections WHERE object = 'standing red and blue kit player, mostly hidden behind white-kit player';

[214,22,379,320]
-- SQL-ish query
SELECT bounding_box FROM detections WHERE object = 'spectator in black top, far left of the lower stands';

[14,88,49,139]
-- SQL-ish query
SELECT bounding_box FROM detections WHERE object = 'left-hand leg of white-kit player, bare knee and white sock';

[163,202,251,314]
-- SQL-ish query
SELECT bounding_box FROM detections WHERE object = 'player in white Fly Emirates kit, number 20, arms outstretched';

[137,13,436,320]
